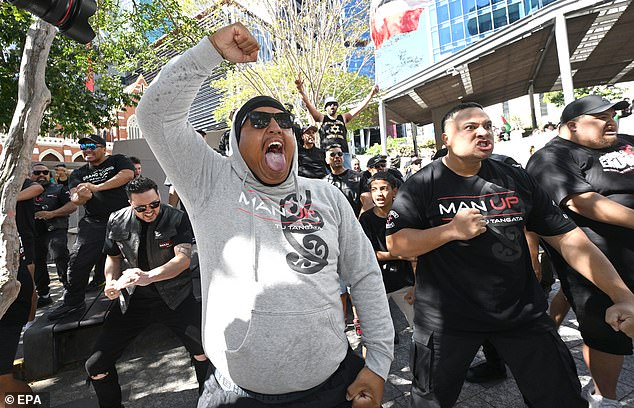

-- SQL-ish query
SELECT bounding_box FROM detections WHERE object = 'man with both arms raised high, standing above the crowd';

[295,75,379,169]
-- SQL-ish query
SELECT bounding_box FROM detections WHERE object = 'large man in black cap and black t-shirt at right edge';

[526,95,634,406]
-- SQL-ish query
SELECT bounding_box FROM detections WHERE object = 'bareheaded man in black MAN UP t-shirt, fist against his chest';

[386,102,634,408]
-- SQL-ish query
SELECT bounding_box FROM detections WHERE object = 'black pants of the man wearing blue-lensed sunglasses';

[64,218,106,306]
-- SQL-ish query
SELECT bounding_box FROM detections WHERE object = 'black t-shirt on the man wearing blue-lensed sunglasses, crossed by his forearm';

[68,154,134,222]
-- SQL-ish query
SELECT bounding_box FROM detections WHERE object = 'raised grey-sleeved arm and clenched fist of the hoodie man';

[136,23,259,201]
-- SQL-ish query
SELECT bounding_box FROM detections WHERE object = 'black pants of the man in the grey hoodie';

[198,349,365,408]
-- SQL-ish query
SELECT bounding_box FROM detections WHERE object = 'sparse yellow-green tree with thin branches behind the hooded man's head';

[212,0,376,131]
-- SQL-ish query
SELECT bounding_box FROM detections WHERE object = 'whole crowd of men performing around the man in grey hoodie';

[0,23,634,408]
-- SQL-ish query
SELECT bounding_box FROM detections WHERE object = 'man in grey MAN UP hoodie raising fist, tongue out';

[137,23,394,408]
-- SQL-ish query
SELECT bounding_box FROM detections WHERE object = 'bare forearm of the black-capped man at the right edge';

[564,192,634,229]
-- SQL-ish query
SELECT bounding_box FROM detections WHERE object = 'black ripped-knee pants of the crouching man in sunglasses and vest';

[86,295,205,408]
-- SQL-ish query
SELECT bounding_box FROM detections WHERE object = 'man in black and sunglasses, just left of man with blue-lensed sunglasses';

[31,163,77,308]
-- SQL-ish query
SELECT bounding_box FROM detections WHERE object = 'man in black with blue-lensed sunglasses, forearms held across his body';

[48,135,135,320]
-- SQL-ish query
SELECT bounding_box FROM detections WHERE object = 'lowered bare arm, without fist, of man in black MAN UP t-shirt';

[542,228,634,303]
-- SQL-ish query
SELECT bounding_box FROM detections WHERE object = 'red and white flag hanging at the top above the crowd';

[370,0,430,48]
